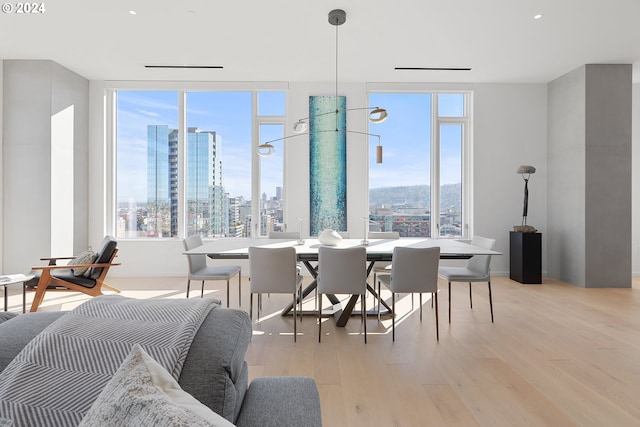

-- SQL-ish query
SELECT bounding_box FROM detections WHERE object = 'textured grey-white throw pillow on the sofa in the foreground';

[79,344,233,427]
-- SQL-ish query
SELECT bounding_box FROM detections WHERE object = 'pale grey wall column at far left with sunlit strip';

[2,60,89,273]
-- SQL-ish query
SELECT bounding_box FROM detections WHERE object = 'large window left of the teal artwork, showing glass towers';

[116,90,285,238]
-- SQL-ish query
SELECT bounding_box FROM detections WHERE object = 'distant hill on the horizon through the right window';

[369,183,462,211]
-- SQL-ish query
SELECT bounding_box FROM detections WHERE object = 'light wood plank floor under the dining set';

[10,277,640,427]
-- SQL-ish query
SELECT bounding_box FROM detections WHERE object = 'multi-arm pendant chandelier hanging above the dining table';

[257,9,388,163]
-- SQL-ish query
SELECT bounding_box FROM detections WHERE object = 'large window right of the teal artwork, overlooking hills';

[369,93,469,237]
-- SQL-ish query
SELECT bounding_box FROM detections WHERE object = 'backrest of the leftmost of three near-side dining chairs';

[249,246,298,294]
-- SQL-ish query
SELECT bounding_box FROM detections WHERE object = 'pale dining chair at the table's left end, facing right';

[183,235,242,307]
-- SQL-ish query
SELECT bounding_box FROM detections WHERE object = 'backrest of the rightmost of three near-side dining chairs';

[390,246,440,293]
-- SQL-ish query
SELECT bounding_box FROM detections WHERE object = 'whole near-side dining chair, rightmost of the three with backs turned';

[378,246,440,341]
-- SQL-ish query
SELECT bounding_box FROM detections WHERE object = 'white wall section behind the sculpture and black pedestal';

[473,84,547,275]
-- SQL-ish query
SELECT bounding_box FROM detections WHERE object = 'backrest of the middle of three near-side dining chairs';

[317,246,367,294]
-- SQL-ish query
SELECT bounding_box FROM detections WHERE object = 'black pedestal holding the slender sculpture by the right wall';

[509,231,542,284]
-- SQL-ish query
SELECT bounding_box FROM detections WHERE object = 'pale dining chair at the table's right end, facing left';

[438,236,496,323]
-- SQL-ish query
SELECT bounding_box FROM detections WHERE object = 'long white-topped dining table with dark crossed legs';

[183,237,502,327]
